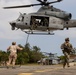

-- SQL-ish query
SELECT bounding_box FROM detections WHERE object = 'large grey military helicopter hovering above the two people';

[3,0,76,34]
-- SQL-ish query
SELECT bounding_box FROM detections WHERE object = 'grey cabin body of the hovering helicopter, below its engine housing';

[10,14,64,31]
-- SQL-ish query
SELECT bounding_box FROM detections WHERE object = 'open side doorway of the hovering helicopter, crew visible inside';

[30,16,49,28]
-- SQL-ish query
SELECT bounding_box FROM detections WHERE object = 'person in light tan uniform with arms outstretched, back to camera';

[7,42,22,67]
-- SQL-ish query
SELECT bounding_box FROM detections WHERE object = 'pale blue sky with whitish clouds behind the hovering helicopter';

[0,0,76,55]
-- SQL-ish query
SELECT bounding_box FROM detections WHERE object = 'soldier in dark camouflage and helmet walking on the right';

[61,38,73,68]
